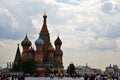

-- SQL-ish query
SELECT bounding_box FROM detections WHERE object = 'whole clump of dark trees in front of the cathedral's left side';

[12,57,37,75]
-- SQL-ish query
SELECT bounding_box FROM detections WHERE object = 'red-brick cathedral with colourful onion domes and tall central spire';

[14,13,63,75]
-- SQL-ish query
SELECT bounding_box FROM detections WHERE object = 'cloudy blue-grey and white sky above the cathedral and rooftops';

[0,0,120,70]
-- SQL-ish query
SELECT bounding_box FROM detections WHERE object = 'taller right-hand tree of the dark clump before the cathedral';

[22,57,37,75]
